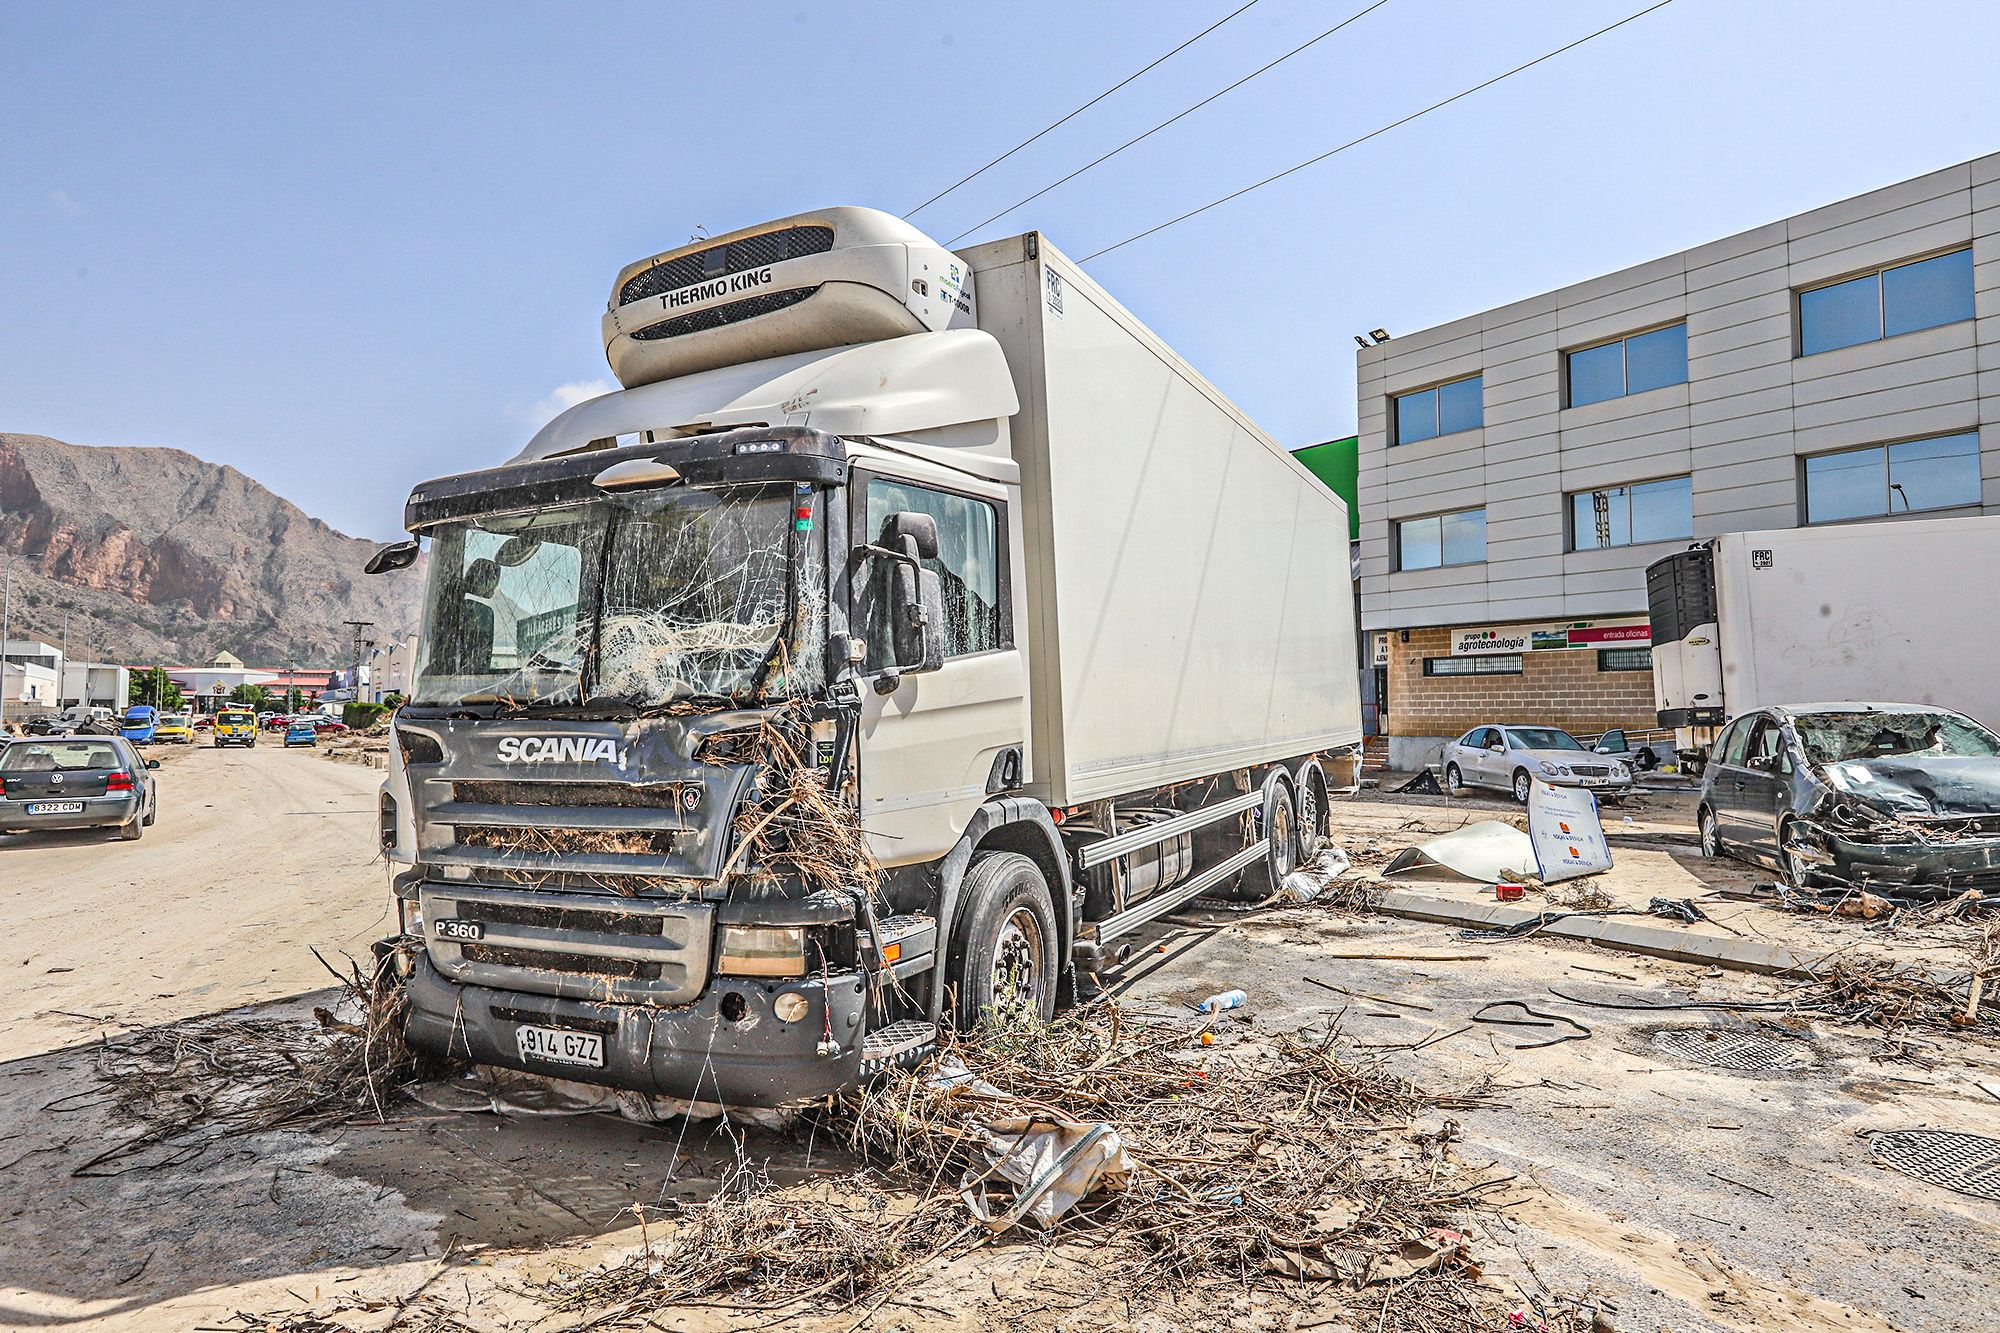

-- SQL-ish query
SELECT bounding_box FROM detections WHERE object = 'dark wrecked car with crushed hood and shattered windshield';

[1694,703,2000,897]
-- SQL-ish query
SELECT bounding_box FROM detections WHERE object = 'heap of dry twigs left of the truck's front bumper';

[76,945,444,1175]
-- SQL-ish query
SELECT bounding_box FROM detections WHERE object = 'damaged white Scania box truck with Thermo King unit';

[370,208,1360,1107]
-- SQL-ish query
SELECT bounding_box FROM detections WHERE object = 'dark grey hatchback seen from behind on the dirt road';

[0,737,160,841]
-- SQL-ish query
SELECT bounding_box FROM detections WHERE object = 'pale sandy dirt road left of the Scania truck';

[0,739,388,1061]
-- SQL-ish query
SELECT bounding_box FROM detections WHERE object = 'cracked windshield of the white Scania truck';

[418,486,824,707]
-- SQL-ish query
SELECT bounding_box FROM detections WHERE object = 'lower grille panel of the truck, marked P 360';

[418,883,714,1005]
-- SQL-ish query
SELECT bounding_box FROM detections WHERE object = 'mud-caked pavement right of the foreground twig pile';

[1122,909,2000,1333]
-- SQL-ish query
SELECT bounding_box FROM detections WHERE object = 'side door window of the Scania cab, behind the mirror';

[858,478,1006,671]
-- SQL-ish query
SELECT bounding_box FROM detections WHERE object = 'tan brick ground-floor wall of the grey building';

[1386,628,1658,737]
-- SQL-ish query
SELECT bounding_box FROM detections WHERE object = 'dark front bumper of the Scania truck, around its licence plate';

[404,955,866,1107]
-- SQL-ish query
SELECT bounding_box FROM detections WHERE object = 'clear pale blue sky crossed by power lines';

[0,0,2000,538]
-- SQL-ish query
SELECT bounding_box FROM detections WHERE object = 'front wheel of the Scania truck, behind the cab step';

[950,853,1058,1031]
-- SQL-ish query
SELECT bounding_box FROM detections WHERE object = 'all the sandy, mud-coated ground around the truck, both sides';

[0,747,2000,1333]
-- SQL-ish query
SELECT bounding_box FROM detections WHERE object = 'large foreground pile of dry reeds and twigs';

[548,1005,1500,1327]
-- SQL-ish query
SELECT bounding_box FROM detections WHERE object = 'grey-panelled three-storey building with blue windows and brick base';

[1358,154,2000,769]
